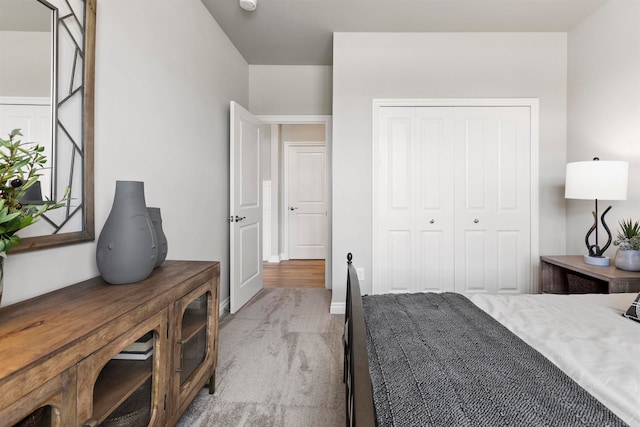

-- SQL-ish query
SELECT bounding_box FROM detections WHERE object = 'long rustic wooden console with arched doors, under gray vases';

[0,261,220,427]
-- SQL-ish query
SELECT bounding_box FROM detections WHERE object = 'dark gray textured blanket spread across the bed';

[363,293,626,427]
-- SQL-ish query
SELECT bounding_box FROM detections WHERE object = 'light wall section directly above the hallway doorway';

[249,65,332,115]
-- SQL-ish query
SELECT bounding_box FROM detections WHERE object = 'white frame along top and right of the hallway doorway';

[256,115,333,289]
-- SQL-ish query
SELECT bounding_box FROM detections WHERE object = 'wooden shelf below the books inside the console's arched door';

[93,356,153,422]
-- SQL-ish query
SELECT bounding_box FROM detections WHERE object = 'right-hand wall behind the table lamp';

[567,0,640,257]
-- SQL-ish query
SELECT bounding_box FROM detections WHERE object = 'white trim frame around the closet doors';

[371,98,540,293]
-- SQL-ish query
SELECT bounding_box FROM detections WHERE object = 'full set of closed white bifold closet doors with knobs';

[373,107,531,293]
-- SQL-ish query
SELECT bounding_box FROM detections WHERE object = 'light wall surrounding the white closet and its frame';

[332,33,567,310]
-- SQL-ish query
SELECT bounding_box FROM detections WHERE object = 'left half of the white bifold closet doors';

[373,107,455,293]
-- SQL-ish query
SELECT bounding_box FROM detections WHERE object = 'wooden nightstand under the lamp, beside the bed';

[540,255,640,294]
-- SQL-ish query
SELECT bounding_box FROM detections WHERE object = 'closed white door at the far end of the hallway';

[286,144,327,259]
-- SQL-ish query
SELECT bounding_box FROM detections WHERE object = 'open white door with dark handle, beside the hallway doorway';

[229,101,262,313]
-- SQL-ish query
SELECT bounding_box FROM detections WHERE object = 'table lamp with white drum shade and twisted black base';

[564,157,629,266]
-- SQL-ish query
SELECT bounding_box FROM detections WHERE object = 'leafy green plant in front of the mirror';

[0,129,69,252]
